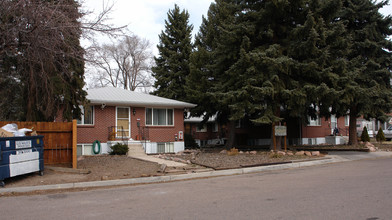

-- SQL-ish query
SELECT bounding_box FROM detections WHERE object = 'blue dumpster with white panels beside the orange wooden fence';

[0,136,44,186]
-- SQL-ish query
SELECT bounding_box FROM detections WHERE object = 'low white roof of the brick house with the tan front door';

[87,87,196,108]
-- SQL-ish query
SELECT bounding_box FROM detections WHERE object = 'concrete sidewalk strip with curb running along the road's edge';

[0,151,392,193]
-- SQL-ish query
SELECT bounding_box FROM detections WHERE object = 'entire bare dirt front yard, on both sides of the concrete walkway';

[4,151,318,188]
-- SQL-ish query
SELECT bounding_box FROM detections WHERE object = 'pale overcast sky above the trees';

[83,0,392,55]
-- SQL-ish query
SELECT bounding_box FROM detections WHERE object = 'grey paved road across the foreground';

[0,158,392,220]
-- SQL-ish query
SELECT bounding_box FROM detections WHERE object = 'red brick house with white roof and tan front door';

[58,87,195,155]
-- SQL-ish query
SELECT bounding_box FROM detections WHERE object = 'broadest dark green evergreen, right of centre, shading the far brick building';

[188,1,337,148]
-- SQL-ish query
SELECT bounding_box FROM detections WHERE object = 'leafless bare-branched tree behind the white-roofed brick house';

[89,34,153,91]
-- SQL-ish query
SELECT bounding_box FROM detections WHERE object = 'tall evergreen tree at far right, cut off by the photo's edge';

[335,0,392,145]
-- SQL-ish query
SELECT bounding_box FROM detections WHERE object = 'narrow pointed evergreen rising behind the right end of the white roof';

[152,5,193,101]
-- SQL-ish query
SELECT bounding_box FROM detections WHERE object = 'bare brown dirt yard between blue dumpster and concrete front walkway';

[4,155,162,188]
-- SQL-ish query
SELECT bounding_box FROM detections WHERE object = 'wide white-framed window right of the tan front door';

[146,108,174,126]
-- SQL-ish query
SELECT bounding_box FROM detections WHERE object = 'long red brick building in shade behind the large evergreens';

[185,115,356,146]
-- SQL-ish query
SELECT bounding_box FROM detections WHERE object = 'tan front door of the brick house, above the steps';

[116,107,131,138]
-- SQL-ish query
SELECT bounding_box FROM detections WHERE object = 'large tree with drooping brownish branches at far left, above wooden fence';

[0,0,86,121]
